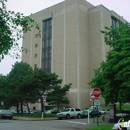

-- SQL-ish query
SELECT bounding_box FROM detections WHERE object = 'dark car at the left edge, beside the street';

[0,110,13,119]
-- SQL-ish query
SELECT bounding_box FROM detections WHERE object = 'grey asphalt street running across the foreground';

[0,118,92,130]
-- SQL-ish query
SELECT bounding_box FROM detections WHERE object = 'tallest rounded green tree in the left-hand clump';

[8,62,38,112]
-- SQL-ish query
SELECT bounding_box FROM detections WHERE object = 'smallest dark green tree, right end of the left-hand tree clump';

[47,84,72,110]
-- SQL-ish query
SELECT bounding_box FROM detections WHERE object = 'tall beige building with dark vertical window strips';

[22,0,125,108]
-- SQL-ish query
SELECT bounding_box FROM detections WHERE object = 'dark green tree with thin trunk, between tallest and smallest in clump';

[33,68,62,111]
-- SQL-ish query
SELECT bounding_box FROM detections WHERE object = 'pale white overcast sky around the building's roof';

[0,0,130,75]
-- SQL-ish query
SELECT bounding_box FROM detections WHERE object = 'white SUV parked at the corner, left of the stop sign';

[57,108,82,119]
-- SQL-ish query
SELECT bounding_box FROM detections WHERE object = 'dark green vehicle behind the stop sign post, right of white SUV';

[82,109,101,118]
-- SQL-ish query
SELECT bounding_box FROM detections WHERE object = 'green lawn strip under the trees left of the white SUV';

[14,113,56,118]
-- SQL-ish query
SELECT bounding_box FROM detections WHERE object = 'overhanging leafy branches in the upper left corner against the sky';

[0,0,40,61]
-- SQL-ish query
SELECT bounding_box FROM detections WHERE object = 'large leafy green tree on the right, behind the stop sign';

[89,23,130,104]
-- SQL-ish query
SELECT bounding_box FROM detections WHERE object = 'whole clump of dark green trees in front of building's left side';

[0,62,71,112]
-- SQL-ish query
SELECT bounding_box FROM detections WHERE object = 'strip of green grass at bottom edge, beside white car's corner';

[86,124,113,130]
